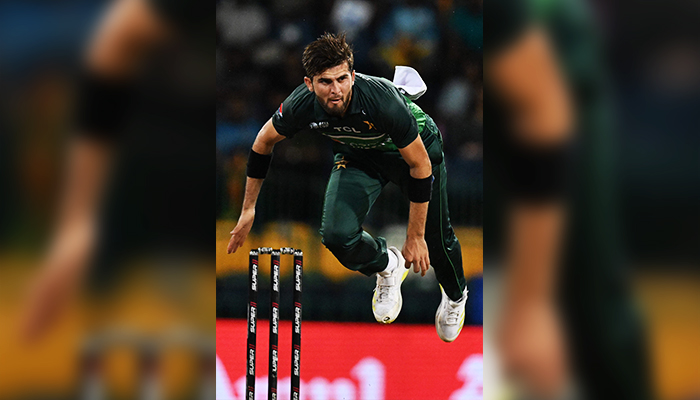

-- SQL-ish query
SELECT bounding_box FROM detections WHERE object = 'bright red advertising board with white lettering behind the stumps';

[216,320,483,400]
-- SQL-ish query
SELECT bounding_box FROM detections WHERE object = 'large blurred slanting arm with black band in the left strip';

[21,0,171,340]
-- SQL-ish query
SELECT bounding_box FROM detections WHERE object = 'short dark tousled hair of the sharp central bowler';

[301,33,355,78]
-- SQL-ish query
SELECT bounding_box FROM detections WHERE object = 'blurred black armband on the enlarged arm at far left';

[76,72,134,138]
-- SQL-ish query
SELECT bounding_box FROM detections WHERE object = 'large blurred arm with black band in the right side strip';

[485,28,574,398]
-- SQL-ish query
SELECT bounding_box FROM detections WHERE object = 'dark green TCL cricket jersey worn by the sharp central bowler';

[272,73,442,164]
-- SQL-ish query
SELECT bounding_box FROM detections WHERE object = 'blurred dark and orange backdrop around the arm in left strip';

[0,0,215,399]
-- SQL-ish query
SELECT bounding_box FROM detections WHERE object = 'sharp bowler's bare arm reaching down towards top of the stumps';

[227,119,285,254]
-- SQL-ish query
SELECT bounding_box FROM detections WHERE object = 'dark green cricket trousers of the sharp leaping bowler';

[320,143,466,300]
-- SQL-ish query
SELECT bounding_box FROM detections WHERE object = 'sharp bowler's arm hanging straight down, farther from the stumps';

[399,135,433,276]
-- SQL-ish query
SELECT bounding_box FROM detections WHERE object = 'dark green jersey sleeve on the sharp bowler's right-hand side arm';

[374,86,418,149]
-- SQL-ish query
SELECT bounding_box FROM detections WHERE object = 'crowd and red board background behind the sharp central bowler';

[216,0,483,399]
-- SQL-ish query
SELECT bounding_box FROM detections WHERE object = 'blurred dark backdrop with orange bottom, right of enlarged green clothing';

[594,0,700,399]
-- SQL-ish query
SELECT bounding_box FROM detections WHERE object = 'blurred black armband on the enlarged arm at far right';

[505,143,573,201]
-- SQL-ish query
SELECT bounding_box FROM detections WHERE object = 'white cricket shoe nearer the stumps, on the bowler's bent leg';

[372,246,410,324]
